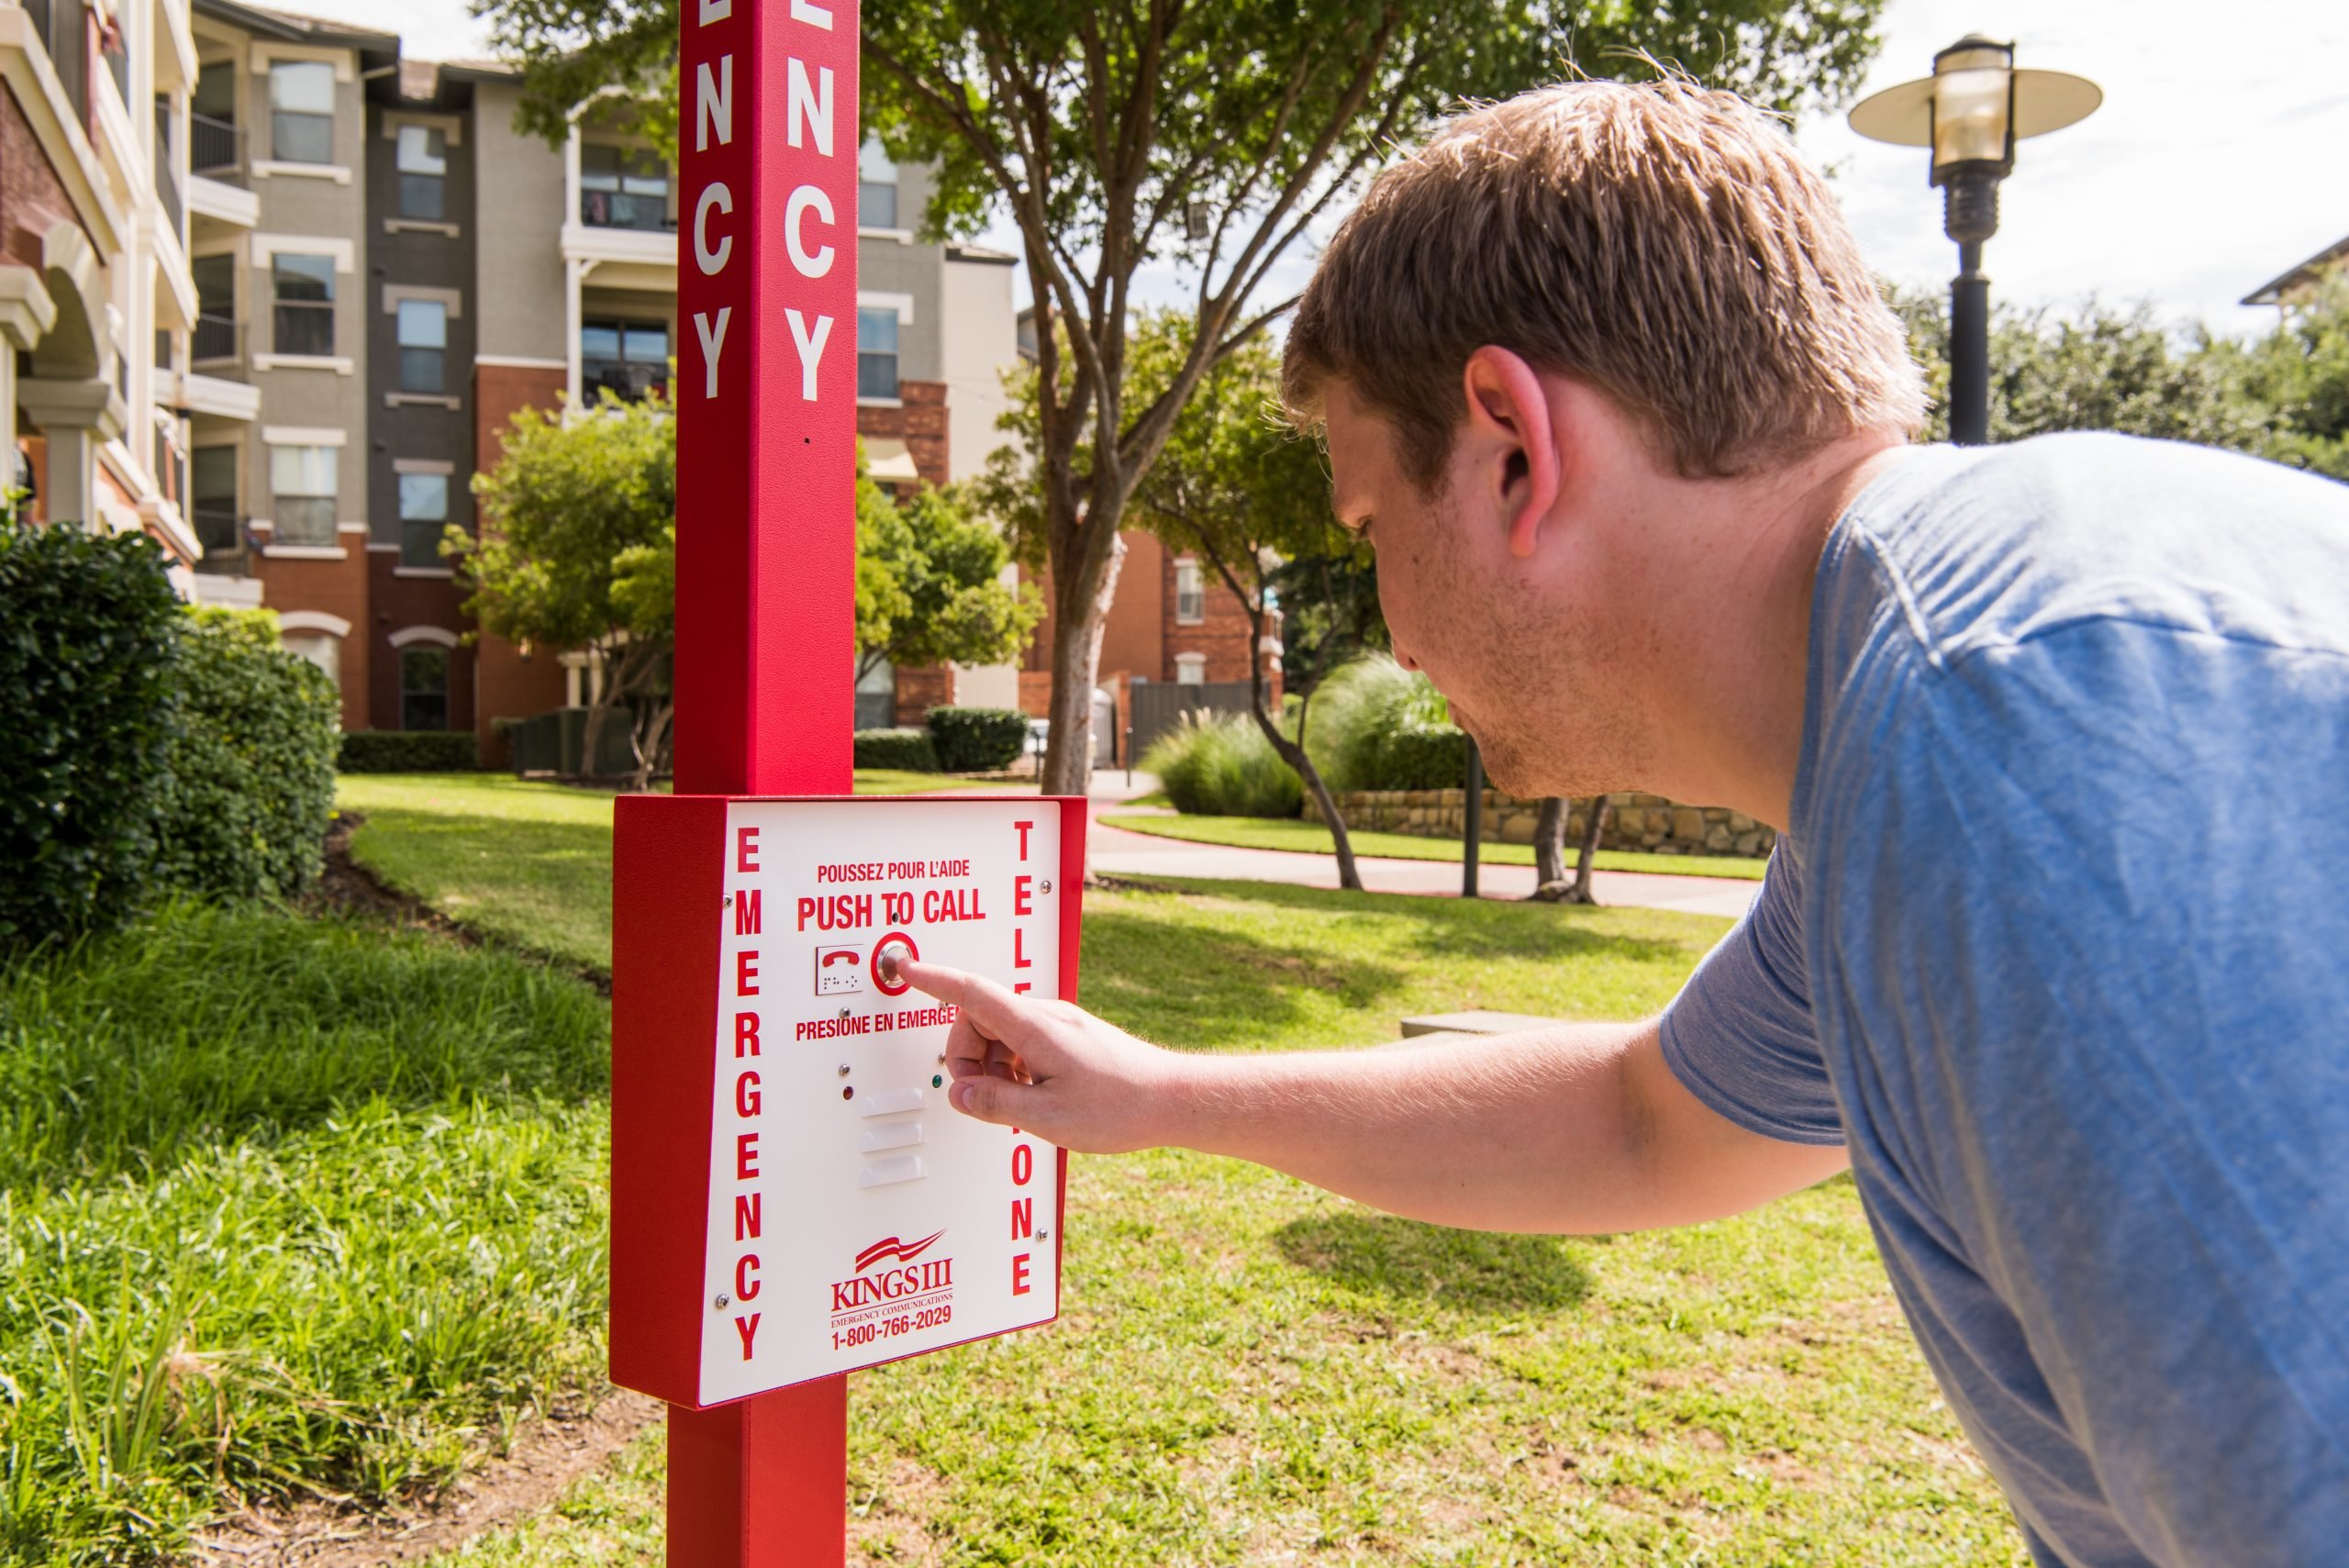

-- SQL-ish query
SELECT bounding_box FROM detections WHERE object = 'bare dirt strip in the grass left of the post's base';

[185,1390,662,1568]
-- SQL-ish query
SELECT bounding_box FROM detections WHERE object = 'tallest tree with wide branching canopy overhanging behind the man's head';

[474,0,1882,794]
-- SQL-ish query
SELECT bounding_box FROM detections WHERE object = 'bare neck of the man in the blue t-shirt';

[1649,434,1905,828]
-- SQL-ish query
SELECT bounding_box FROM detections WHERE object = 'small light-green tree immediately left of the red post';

[458,392,676,789]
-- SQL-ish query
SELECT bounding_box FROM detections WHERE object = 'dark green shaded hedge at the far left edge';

[0,512,179,946]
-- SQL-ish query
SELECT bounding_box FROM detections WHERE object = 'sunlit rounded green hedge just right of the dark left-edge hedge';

[155,608,343,899]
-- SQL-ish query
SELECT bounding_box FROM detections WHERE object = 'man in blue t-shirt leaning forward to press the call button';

[914,83,2349,1568]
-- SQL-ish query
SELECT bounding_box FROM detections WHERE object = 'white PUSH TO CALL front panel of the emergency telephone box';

[700,800,1071,1404]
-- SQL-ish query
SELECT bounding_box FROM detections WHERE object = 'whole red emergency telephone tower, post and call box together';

[611,0,1085,1568]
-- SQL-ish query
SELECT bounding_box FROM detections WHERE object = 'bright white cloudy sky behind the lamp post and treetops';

[303,0,2349,336]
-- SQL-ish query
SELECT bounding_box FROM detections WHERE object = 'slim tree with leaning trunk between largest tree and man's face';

[1134,312,1363,892]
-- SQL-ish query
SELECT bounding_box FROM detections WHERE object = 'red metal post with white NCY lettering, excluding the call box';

[670,0,857,1568]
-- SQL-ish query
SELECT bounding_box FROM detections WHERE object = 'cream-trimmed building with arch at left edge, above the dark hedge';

[0,0,202,592]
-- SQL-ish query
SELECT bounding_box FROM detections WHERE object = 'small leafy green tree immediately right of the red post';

[857,455,1043,681]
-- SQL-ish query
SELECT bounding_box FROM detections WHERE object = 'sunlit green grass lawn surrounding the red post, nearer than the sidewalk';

[0,777,2025,1568]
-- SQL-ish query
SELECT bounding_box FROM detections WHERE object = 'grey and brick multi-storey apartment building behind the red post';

[170,0,1017,762]
